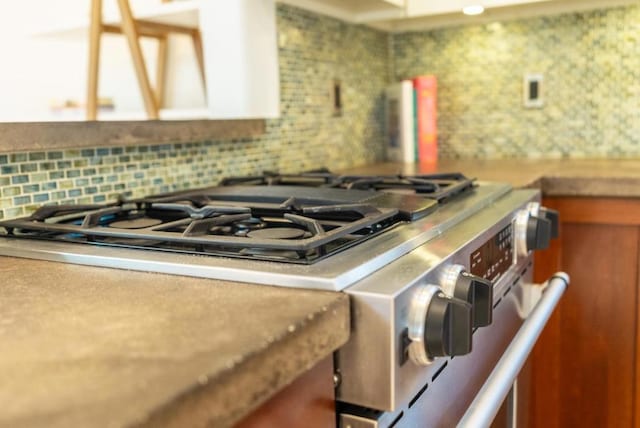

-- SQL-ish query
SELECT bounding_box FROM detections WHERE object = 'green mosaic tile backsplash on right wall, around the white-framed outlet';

[392,2,640,158]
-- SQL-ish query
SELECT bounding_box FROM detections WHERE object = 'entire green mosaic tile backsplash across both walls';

[0,1,640,219]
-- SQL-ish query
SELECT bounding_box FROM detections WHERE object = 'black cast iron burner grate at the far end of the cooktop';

[220,168,474,203]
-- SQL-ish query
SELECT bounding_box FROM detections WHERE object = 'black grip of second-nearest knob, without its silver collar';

[453,271,493,328]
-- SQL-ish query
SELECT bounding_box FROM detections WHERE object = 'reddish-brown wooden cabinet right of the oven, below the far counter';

[529,198,640,428]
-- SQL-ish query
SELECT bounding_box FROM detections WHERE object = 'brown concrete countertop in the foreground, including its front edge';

[0,257,349,428]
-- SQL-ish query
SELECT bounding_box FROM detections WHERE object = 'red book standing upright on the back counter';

[413,76,438,163]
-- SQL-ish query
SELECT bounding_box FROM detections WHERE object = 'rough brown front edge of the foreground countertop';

[133,293,350,428]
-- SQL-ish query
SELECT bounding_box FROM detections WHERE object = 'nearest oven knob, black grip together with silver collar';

[409,285,472,365]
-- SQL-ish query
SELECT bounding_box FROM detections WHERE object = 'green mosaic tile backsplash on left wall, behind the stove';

[0,5,390,219]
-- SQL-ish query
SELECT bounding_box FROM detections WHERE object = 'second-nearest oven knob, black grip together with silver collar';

[440,264,493,328]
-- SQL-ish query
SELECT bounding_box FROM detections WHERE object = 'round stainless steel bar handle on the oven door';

[458,272,569,428]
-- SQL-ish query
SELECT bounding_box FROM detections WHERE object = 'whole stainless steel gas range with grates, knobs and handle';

[0,170,568,428]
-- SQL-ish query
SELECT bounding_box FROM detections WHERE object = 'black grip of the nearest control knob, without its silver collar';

[424,292,472,358]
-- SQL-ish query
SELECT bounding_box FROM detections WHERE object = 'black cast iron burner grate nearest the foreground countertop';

[0,196,399,264]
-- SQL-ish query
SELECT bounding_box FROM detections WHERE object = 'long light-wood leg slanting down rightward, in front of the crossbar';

[118,0,159,119]
